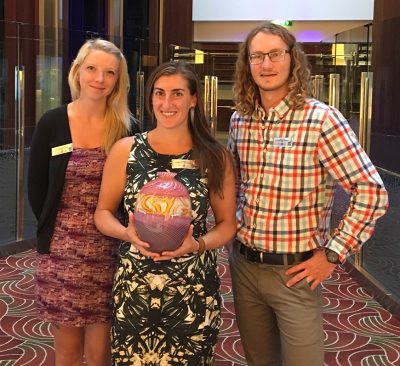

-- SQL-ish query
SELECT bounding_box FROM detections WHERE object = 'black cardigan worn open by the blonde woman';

[28,105,140,254]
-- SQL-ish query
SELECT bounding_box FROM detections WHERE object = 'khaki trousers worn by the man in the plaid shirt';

[229,245,324,366]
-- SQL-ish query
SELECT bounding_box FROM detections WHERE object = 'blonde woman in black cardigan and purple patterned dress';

[28,39,131,366]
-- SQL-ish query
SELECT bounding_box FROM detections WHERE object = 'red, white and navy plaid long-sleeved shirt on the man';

[228,99,388,260]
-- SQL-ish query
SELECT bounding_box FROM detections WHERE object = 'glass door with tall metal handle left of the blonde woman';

[0,21,63,250]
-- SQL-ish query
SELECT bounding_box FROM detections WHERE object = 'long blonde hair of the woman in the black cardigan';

[68,38,132,152]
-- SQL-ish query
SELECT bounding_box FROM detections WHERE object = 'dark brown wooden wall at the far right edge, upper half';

[371,0,400,173]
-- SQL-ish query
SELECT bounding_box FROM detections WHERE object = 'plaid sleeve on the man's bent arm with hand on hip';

[318,108,388,261]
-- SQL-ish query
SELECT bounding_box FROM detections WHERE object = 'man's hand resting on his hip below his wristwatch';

[286,249,336,290]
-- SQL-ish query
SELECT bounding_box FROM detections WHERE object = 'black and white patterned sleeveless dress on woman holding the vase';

[112,132,221,366]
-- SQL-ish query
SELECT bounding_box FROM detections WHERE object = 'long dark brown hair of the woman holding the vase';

[146,61,233,197]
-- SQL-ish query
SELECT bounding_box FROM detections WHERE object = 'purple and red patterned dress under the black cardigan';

[36,148,118,327]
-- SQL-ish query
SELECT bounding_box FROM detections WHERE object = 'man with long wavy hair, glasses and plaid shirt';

[228,23,387,366]
